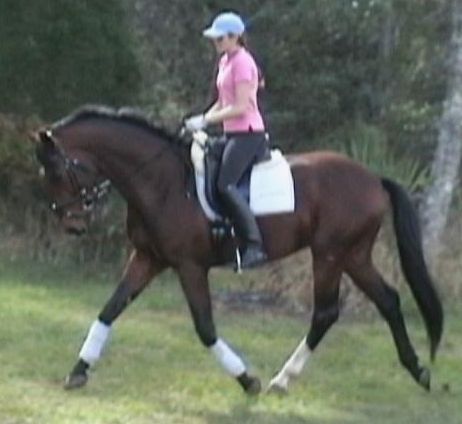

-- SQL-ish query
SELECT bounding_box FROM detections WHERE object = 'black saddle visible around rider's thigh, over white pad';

[204,136,271,221]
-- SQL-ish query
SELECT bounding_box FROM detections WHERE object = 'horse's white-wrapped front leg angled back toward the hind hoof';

[177,263,261,395]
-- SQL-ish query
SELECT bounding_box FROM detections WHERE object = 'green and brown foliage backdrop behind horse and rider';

[0,0,461,302]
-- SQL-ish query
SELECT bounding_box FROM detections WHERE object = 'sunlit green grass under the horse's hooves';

[0,263,462,424]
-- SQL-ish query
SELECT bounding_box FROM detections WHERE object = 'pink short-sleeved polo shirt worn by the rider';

[217,47,265,132]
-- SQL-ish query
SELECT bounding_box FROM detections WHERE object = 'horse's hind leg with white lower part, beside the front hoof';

[268,254,342,393]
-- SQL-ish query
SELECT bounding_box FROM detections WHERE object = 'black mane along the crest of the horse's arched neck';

[51,105,178,143]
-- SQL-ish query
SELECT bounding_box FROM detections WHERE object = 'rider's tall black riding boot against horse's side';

[222,185,268,268]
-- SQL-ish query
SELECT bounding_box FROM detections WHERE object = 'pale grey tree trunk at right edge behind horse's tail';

[422,0,462,260]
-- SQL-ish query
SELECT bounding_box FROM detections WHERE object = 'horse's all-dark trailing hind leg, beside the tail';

[346,252,430,390]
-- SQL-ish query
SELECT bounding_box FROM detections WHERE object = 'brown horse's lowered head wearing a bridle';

[31,129,109,235]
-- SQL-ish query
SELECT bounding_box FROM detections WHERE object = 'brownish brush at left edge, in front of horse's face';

[0,115,127,266]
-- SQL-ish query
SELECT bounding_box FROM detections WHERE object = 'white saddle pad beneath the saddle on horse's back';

[191,133,295,221]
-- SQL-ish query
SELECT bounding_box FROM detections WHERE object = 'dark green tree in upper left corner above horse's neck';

[0,0,139,119]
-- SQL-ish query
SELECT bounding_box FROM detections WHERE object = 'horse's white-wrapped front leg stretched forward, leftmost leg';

[64,250,164,389]
